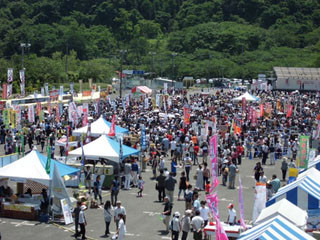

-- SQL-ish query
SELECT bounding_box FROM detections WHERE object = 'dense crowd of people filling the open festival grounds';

[0,86,320,239]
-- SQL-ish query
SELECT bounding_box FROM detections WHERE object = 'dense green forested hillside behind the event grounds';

[0,0,320,88]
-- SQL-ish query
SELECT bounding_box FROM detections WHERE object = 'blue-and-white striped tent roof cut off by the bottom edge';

[238,216,315,240]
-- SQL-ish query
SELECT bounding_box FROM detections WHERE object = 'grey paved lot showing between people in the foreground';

[0,147,280,240]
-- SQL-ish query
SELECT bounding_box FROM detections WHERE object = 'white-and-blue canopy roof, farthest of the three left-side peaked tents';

[72,115,129,136]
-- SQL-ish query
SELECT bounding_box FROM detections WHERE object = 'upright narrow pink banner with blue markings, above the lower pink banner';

[209,135,219,193]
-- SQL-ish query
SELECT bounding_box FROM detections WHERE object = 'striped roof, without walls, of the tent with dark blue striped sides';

[269,175,320,201]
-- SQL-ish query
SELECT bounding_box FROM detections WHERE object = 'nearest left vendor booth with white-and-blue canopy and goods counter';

[0,150,79,220]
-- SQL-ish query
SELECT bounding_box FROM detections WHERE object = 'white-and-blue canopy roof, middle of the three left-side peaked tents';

[69,135,139,163]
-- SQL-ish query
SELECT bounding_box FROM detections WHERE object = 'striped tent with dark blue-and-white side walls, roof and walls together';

[266,169,320,210]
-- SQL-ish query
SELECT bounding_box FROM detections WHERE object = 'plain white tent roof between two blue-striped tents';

[255,199,308,228]
